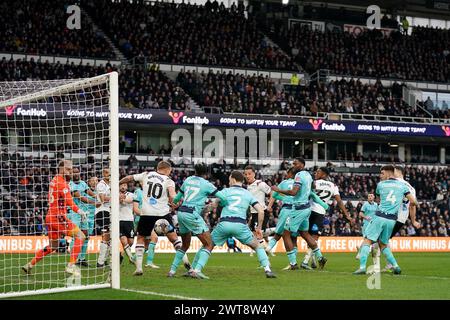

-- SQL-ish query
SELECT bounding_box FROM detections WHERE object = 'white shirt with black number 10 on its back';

[133,171,175,217]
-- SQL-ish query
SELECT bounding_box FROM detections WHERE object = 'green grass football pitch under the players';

[2,253,450,300]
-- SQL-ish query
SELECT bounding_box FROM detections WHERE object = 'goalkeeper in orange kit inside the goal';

[22,160,87,276]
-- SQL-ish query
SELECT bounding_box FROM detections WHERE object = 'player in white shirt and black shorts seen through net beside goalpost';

[95,168,111,268]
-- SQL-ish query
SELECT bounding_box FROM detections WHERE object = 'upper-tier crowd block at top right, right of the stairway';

[273,24,450,82]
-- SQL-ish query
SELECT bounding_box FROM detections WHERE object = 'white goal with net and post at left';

[0,72,120,297]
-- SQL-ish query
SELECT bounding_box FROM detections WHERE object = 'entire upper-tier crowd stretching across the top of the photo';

[0,0,450,86]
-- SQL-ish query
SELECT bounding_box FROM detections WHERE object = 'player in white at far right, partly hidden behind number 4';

[378,166,420,271]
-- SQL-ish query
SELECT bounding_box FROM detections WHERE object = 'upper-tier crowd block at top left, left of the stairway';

[0,0,115,59]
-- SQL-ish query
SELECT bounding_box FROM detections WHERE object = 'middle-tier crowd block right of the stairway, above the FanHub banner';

[177,71,449,117]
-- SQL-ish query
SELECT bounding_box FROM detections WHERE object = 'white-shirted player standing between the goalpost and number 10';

[119,183,134,263]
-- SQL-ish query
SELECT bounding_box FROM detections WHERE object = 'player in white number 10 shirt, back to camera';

[120,161,190,276]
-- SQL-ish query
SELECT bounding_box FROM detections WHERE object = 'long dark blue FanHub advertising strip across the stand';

[0,105,450,137]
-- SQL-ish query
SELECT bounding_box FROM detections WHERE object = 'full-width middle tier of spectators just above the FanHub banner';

[0,58,450,119]
